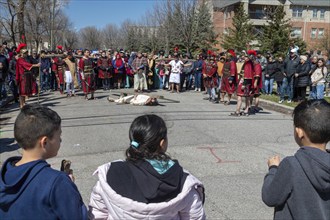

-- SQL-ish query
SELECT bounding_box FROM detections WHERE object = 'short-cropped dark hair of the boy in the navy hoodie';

[14,104,61,150]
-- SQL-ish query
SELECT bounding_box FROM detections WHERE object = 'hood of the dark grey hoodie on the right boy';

[295,147,330,192]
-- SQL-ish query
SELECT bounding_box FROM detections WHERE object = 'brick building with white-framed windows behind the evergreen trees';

[208,0,330,50]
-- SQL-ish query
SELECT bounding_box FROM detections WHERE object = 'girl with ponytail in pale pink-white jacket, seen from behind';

[89,115,206,220]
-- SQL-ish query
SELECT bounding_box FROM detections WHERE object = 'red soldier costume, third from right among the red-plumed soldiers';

[221,60,237,95]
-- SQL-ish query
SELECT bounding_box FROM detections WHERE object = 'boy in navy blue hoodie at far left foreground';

[0,105,87,220]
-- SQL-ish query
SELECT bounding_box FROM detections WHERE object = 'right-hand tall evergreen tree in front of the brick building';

[258,6,306,55]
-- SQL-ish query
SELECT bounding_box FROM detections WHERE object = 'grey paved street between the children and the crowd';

[0,88,298,219]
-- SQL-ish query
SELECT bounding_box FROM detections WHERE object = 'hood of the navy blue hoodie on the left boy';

[0,157,50,206]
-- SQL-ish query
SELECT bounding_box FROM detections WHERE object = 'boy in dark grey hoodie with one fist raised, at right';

[262,100,330,220]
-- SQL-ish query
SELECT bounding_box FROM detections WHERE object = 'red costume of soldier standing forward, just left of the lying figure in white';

[79,57,95,96]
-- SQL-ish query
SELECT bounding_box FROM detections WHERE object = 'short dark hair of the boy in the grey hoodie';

[292,99,330,144]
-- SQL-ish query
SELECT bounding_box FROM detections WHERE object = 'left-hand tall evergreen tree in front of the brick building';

[221,4,254,51]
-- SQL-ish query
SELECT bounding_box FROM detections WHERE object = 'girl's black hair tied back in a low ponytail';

[126,114,171,161]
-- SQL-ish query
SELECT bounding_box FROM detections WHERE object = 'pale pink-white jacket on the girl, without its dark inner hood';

[90,160,204,219]
